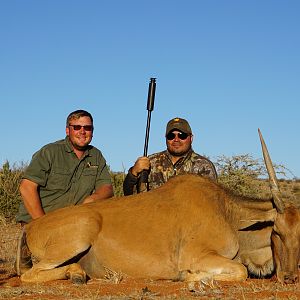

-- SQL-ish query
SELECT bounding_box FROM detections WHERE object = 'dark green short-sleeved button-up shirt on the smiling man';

[17,137,111,222]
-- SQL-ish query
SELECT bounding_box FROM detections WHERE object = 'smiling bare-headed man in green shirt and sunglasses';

[16,110,113,273]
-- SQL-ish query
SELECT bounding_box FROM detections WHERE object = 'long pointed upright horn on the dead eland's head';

[258,128,284,213]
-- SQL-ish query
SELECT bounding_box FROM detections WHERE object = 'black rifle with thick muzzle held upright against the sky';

[137,78,156,193]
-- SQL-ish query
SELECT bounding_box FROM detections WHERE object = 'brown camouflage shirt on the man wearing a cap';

[123,149,217,195]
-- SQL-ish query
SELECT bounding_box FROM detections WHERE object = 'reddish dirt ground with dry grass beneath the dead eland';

[0,223,300,300]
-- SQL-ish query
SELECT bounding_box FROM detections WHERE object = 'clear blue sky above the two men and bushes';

[0,0,300,177]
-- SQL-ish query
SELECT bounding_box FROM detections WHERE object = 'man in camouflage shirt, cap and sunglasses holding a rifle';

[123,118,217,195]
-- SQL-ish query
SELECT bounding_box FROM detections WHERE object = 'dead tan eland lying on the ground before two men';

[17,132,300,283]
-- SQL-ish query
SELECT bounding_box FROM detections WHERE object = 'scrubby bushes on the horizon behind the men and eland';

[0,154,300,220]
